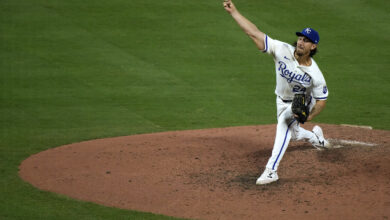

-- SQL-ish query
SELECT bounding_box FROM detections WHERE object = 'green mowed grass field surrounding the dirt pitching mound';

[0,0,390,219]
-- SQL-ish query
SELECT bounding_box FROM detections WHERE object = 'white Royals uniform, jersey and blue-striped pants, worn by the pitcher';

[263,35,329,171]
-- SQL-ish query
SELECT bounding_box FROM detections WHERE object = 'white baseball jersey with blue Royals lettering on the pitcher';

[263,35,329,100]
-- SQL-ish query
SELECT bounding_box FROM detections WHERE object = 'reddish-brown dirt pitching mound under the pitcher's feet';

[20,124,390,219]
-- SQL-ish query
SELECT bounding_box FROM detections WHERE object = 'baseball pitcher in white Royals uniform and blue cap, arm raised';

[223,0,330,185]
